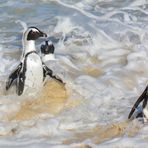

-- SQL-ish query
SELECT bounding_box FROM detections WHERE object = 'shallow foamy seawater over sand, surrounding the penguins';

[0,0,148,148]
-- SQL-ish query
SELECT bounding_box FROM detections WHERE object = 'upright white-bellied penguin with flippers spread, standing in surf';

[6,27,63,96]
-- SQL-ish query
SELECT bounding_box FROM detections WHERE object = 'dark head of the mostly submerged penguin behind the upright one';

[41,41,54,54]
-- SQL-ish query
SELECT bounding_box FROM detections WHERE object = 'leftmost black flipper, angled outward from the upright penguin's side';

[6,63,22,90]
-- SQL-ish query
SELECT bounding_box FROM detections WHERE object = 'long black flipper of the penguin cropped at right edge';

[128,86,148,119]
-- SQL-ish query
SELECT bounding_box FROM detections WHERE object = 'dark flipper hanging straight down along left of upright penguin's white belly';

[16,64,26,96]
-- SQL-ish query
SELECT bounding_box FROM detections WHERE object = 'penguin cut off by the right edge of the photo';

[128,86,148,122]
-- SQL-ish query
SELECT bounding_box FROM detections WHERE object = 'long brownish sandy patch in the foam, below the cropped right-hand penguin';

[63,121,141,145]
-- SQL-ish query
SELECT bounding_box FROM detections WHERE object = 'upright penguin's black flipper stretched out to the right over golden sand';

[43,63,64,84]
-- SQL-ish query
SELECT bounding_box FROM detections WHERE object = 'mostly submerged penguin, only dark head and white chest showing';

[41,40,56,62]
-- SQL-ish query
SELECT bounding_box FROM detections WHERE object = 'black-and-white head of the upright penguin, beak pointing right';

[24,27,47,41]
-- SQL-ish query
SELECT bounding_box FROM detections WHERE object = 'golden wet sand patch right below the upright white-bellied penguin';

[11,80,67,120]
